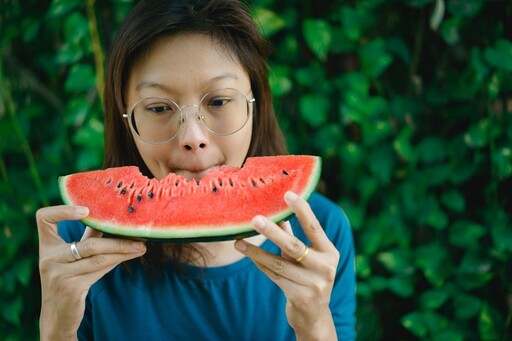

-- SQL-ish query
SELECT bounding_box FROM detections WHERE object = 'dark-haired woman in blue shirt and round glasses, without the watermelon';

[37,0,355,340]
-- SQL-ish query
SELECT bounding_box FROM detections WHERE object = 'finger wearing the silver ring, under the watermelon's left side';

[61,238,146,262]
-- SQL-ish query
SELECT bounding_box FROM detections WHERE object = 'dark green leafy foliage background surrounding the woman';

[0,0,512,340]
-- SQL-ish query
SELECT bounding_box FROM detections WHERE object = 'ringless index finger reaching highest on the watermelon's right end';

[284,191,331,251]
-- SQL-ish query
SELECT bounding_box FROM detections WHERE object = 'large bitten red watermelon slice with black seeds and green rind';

[59,155,321,242]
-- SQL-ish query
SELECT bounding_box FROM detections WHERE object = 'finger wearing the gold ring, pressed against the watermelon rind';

[252,215,306,260]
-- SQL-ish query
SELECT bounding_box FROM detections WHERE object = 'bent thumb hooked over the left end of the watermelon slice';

[36,205,89,244]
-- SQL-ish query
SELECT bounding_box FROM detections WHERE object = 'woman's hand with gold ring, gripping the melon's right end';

[235,192,339,340]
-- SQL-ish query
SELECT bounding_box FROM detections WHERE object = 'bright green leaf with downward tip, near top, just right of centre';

[302,19,332,61]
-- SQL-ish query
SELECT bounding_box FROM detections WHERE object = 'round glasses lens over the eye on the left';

[131,97,180,143]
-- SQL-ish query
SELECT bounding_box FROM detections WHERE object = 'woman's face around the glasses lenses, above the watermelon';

[126,33,253,180]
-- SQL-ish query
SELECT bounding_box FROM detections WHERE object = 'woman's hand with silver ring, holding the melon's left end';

[36,206,146,341]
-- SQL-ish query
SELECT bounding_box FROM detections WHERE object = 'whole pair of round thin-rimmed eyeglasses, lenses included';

[123,88,255,144]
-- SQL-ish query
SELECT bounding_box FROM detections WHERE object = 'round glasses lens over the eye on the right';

[199,89,249,135]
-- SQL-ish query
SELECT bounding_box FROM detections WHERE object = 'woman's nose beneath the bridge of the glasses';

[178,105,209,153]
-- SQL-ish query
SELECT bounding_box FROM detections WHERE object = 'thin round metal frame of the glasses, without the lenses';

[123,88,256,144]
